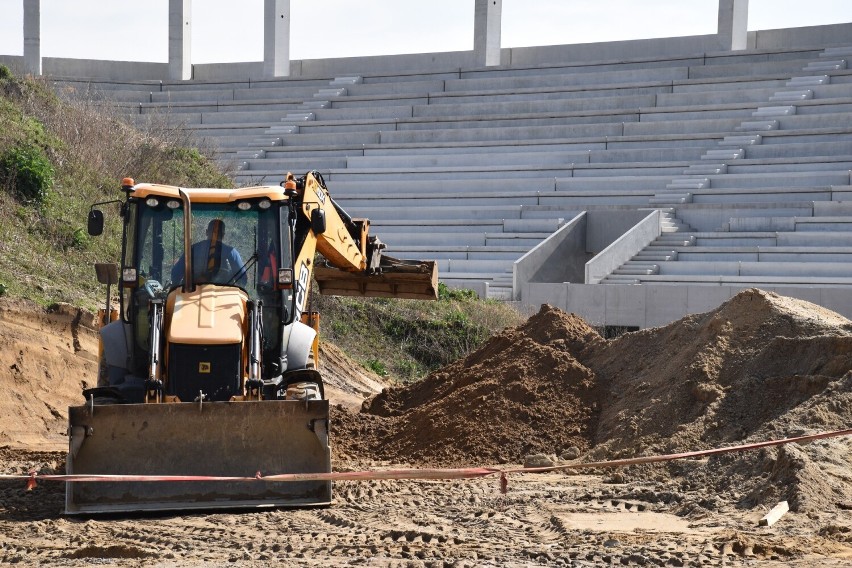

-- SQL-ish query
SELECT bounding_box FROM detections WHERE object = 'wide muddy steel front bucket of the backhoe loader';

[65,400,331,514]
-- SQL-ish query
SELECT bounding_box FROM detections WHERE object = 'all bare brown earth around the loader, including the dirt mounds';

[0,290,852,567]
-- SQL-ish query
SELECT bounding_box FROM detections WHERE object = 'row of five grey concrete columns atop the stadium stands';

[23,0,748,80]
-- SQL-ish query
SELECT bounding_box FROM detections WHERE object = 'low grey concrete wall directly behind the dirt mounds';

[520,282,852,328]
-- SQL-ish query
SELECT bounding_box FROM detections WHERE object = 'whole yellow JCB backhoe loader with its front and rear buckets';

[65,171,438,515]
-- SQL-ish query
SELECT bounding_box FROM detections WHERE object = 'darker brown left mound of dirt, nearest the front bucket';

[336,306,603,465]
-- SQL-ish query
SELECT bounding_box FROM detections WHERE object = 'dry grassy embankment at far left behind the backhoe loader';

[0,66,233,309]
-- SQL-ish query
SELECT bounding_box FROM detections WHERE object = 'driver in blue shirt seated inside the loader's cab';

[172,219,246,288]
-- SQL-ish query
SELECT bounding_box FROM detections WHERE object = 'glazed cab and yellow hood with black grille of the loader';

[120,184,293,400]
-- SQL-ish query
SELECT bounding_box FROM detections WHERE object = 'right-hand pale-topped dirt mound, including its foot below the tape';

[588,289,852,510]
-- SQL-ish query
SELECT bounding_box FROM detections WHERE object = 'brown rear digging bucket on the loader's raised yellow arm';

[314,256,438,300]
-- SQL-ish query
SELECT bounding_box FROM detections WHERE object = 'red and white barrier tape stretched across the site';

[6,428,852,493]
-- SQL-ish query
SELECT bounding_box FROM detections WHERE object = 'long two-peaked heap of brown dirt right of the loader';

[335,290,852,509]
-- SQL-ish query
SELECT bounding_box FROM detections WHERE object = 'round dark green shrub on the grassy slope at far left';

[0,145,56,205]
